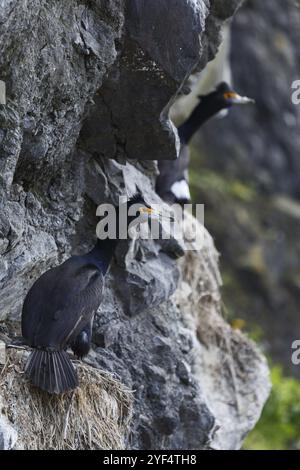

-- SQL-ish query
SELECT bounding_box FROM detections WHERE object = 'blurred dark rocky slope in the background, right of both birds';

[193,0,300,377]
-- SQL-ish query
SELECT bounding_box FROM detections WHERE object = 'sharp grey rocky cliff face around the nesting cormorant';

[0,0,268,449]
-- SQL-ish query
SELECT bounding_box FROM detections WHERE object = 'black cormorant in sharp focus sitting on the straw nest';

[22,196,166,393]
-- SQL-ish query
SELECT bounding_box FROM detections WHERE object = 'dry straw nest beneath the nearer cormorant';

[0,349,132,449]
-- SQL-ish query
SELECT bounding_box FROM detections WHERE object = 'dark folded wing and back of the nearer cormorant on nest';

[22,256,104,348]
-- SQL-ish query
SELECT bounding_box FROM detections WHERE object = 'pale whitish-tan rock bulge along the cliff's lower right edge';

[174,215,270,449]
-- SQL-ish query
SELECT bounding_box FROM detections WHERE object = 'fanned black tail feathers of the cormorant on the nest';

[25,349,78,394]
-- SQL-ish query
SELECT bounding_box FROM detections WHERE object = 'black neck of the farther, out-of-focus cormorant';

[178,102,221,144]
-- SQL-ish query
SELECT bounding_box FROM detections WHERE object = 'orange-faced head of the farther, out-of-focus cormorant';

[199,82,255,111]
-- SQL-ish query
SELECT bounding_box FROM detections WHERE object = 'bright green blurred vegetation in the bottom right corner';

[244,366,300,450]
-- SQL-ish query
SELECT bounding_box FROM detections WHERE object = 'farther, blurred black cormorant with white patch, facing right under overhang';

[156,82,254,204]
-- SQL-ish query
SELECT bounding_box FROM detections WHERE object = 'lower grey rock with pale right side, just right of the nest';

[93,215,270,449]
